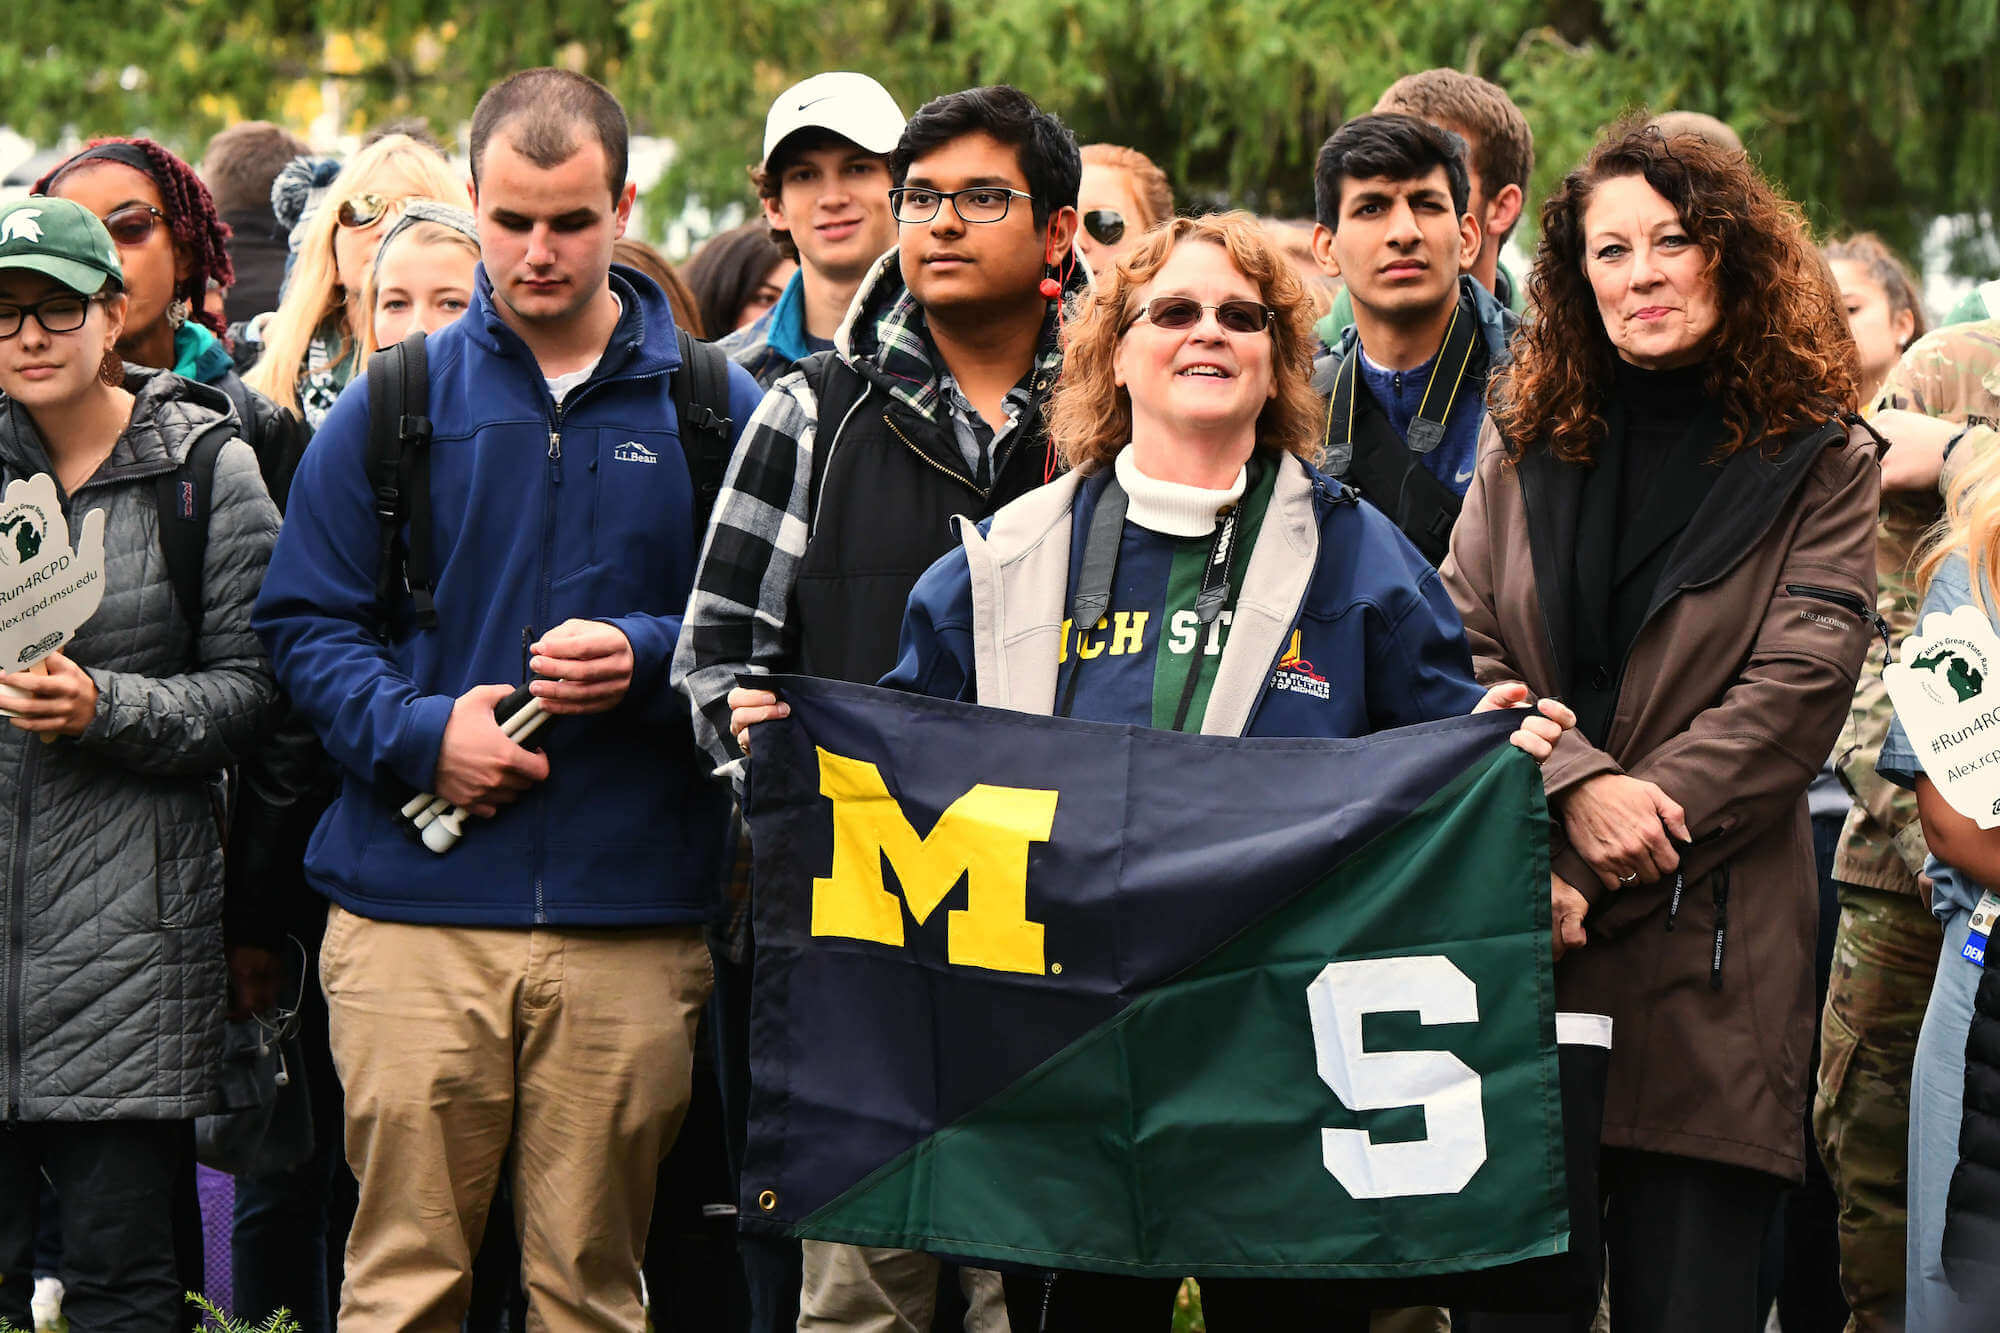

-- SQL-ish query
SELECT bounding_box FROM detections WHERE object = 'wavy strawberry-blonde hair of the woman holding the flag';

[1048,210,1326,472]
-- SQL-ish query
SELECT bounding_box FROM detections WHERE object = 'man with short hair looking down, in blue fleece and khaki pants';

[256,70,758,1329]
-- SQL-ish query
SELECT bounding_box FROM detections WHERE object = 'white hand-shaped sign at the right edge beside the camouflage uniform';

[1882,606,2000,829]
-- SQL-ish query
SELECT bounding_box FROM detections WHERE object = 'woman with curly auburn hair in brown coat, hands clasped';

[1444,122,1878,1333]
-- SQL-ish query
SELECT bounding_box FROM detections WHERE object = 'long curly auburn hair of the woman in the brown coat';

[1486,118,1860,462]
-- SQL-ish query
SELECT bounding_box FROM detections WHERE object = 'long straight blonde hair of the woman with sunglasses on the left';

[244,134,470,414]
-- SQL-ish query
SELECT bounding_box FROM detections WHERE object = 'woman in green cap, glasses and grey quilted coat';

[0,198,278,1329]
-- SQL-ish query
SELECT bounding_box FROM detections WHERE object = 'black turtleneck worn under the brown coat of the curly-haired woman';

[1570,360,1724,745]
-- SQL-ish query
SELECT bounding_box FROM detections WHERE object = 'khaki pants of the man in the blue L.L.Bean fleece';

[320,907,714,1333]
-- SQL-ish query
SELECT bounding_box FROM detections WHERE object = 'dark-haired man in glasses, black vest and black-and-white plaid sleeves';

[674,86,1088,1331]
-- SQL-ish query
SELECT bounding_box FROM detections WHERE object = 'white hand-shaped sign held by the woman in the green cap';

[0,472,104,717]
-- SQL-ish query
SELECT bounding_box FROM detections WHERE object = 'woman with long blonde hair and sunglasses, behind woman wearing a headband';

[244,134,470,430]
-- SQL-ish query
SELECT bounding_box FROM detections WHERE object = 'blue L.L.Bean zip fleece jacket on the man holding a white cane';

[254,266,760,927]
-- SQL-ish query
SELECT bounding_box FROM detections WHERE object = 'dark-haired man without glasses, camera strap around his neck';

[1312,114,1518,564]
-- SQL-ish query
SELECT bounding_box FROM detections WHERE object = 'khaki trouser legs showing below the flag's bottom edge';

[798,1241,1008,1333]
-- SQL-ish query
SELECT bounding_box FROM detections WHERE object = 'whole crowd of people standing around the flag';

[0,49,2000,1333]
